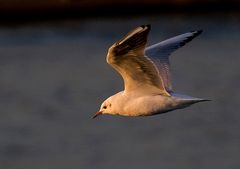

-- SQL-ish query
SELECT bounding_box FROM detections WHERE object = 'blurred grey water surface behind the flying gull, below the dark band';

[0,14,240,169]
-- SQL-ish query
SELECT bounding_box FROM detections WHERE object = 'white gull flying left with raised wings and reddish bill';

[92,24,210,118]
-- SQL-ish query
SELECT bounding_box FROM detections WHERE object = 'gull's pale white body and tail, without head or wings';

[109,92,204,116]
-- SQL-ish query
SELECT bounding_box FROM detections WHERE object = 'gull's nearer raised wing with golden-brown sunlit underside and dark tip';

[107,25,169,96]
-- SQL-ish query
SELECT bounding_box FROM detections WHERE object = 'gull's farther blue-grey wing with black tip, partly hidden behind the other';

[145,30,202,92]
